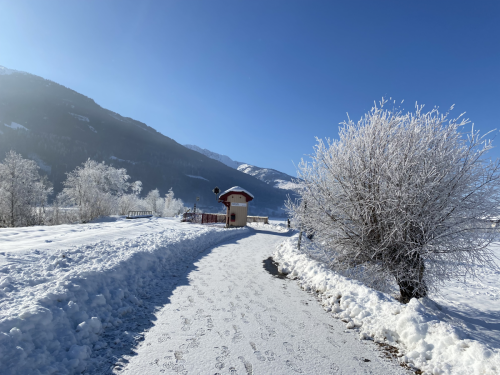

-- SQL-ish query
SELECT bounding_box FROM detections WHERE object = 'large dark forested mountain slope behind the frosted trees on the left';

[0,67,286,215]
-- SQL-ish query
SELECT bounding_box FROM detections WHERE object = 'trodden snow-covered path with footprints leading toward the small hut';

[113,230,407,375]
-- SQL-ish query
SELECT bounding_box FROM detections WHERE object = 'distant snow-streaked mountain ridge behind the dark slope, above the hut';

[184,145,296,190]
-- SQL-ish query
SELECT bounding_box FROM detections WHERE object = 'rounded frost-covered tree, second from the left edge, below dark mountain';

[61,159,130,222]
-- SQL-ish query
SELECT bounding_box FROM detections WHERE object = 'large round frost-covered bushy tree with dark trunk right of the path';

[287,100,500,302]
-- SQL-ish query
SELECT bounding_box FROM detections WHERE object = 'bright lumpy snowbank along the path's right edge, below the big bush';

[273,235,500,374]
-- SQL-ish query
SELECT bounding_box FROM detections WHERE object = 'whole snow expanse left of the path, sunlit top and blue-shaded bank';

[0,218,250,375]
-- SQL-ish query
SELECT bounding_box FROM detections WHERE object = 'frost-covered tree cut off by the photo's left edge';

[0,151,52,227]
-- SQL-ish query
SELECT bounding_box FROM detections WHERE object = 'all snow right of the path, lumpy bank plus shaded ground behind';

[273,235,500,375]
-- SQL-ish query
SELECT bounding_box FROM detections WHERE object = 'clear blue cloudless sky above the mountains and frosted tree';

[0,0,500,175]
